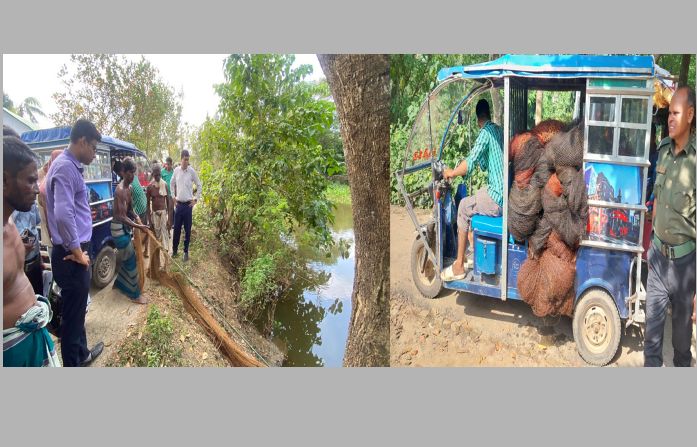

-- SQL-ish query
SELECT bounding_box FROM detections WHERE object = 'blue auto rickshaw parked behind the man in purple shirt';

[21,126,149,288]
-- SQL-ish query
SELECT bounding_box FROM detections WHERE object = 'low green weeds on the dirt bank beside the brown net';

[112,304,182,367]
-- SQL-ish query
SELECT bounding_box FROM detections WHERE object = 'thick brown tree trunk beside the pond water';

[318,54,390,366]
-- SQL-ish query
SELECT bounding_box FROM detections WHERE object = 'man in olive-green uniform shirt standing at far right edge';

[644,87,695,366]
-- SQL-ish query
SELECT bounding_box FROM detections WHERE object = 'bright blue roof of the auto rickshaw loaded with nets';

[438,54,655,85]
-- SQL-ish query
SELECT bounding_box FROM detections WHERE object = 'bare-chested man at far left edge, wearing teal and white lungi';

[2,137,60,366]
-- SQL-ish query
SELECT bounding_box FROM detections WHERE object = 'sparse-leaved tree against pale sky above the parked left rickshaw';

[51,54,182,157]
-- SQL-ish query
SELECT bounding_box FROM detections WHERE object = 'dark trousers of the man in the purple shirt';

[51,245,92,366]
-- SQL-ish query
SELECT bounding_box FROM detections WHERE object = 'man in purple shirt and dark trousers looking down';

[46,119,104,366]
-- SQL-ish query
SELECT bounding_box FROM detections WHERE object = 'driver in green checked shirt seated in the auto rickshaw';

[441,99,503,281]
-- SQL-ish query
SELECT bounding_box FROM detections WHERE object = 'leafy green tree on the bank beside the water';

[194,54,337,318]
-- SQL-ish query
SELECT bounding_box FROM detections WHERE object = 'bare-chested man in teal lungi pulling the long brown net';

[111,157,148,304]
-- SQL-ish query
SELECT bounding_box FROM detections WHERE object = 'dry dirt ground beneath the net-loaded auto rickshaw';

[390,206,694,366]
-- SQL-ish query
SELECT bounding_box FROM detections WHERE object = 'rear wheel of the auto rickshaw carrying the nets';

[572,289,622,366]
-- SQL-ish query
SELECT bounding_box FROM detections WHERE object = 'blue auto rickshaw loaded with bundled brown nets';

[395,55,665,365]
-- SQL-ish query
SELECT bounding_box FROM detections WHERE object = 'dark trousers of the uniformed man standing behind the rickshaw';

[644,243,695,366]
